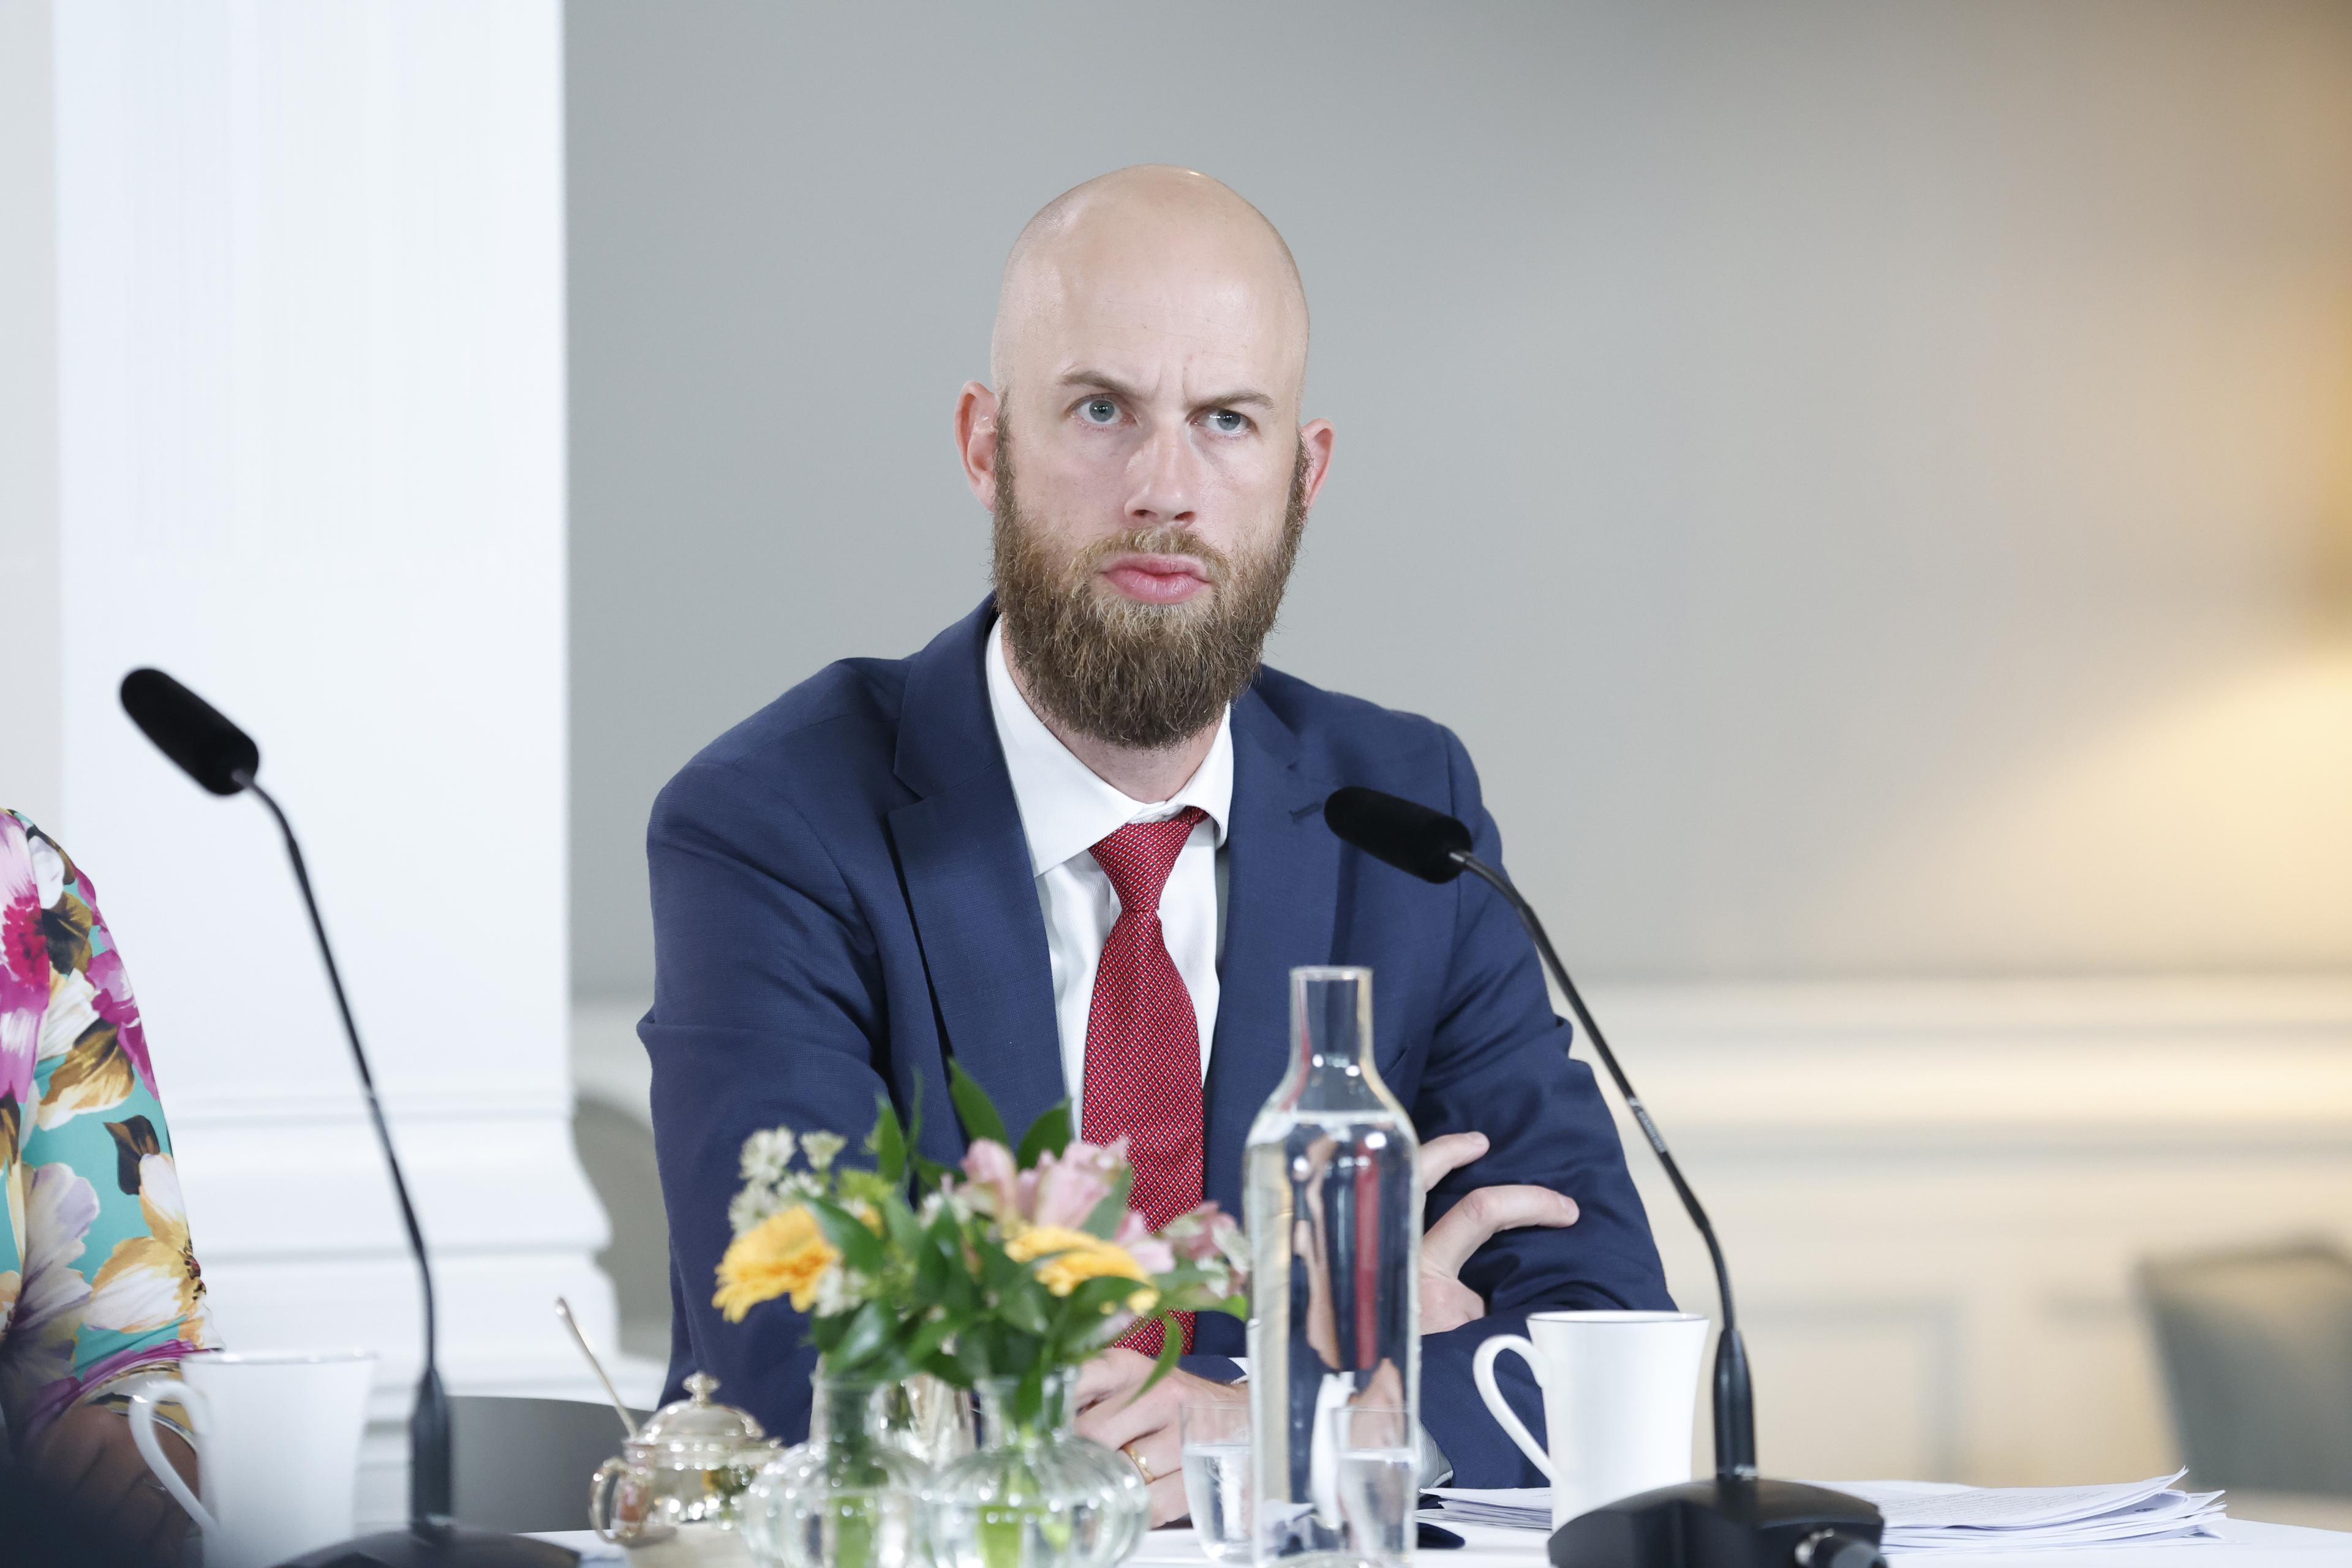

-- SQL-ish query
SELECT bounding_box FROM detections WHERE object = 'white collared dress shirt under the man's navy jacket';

[988,618,1232,1128]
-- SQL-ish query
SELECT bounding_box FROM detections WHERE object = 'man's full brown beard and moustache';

[995,428,1308,750]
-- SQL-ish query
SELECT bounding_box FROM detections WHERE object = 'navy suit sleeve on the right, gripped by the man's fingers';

[1414,733,1675,1486]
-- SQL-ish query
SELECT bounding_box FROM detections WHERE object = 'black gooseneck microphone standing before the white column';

[123,670,579,1568]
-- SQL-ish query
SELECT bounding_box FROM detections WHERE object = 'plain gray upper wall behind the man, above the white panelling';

[567,0,2352,999]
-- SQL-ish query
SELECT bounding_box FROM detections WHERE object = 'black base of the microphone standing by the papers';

[1550,1476,1884,1568]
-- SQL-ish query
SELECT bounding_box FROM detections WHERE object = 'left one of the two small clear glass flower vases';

[736,1373,929,1568]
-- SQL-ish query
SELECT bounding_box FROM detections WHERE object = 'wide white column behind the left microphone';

[51,0,611,1521]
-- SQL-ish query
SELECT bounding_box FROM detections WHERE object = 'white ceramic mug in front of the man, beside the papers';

[1470,1312,1708,1531]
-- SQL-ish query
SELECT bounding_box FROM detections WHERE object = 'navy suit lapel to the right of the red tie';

[1204,689,1341,1218]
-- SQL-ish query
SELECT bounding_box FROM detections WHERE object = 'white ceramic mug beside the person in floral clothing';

[132,1349,376,1568]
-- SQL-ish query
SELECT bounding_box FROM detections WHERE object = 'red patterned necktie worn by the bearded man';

[1080,806,1202,1357]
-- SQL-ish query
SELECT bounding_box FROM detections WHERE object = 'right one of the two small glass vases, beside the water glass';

[924,1371,1150,1568]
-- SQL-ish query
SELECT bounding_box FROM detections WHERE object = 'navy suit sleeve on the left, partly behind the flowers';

[638,762,884,1441]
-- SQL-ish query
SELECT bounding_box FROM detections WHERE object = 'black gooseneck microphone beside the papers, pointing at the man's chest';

[1324,785,1884,1568]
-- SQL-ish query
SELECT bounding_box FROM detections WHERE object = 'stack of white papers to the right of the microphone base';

[1823,1472,2223,1551]
